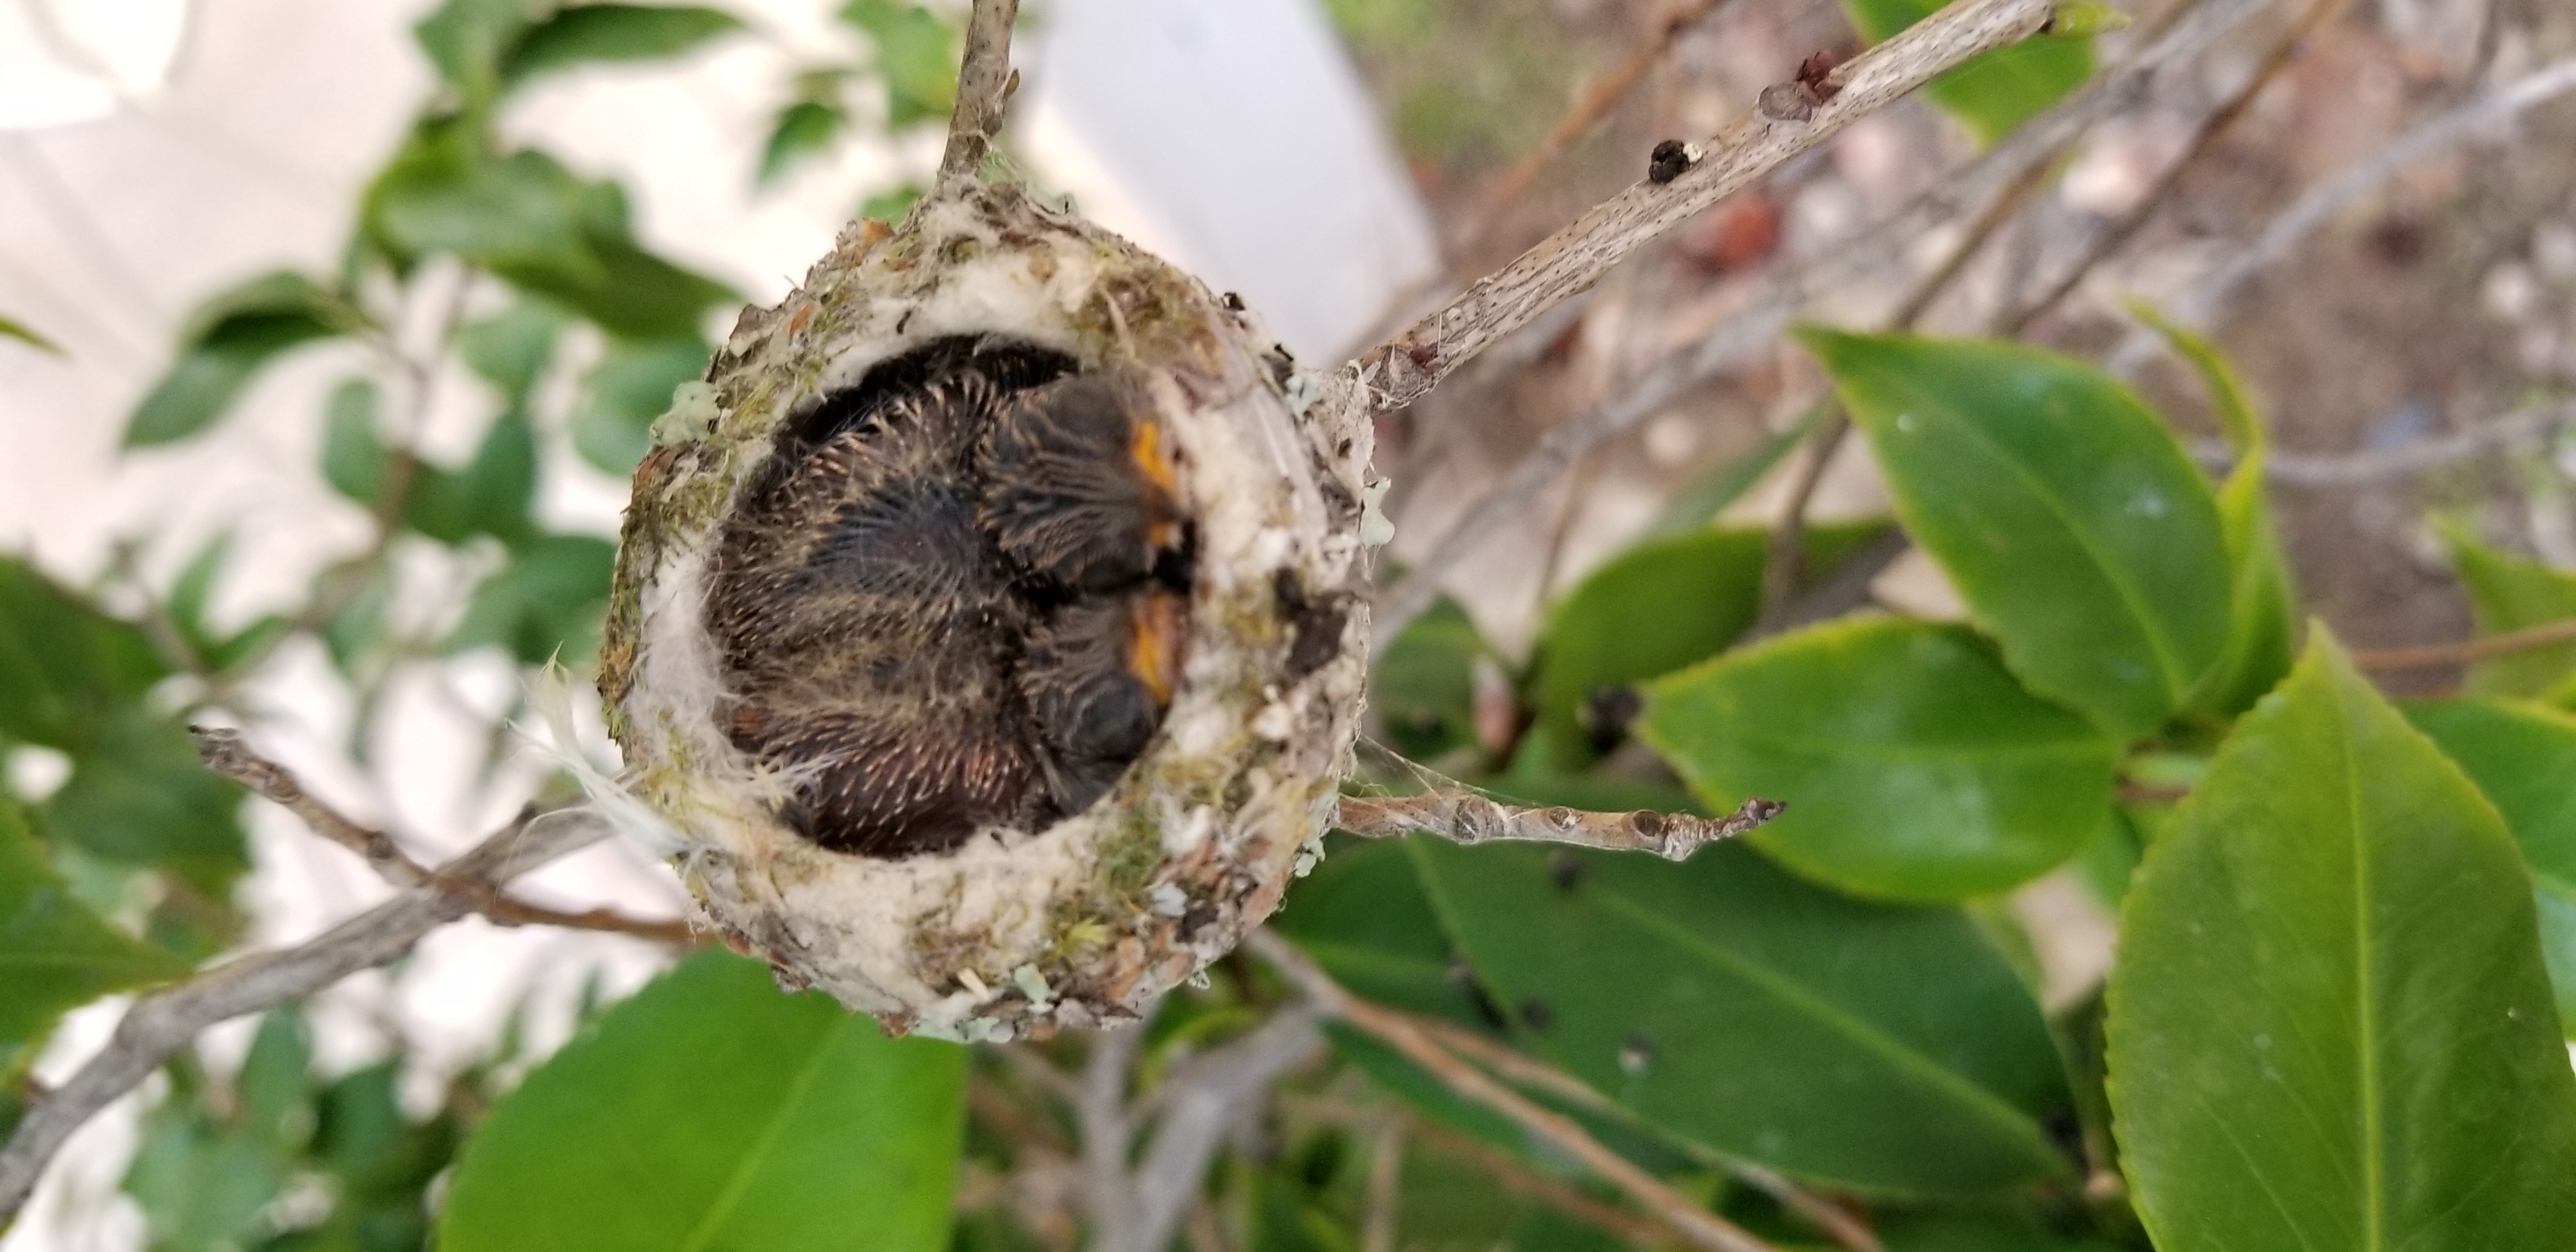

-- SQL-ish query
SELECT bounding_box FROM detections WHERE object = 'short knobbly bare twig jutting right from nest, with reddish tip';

[1335,788,1785,860]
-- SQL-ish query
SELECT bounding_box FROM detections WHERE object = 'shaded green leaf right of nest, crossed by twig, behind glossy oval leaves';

[1530,521,1888,773]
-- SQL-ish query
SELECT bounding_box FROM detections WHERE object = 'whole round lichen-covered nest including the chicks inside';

[600,183,1383,1038]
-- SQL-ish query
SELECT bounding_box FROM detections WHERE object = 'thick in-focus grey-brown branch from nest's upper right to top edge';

[1355,0,2050,412]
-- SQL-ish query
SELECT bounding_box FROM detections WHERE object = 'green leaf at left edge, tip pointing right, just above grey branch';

[0,801,188,1056]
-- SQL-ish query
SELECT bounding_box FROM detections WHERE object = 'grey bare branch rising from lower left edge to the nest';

[0,814,608,1224]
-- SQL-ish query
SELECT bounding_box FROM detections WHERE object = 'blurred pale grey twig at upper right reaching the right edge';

[2110,57,2576,376]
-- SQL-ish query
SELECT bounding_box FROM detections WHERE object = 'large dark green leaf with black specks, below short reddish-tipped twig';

[1406,840,2069,1193]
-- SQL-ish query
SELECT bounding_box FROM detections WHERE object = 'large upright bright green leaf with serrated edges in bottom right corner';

[2110,636,2576,1252]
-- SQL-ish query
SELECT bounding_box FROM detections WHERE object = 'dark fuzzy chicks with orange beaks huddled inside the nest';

[706,340,1188,858]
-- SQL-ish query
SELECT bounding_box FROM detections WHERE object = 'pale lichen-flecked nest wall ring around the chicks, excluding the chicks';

[600,185,1378,1038]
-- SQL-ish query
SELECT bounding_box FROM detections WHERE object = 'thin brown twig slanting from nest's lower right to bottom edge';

[1244,930,1777,1252]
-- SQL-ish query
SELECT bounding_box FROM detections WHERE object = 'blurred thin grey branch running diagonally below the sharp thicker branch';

[1370,0,2267,652]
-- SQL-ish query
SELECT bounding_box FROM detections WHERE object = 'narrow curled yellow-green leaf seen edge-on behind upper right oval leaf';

[2130,307,2298,716]
